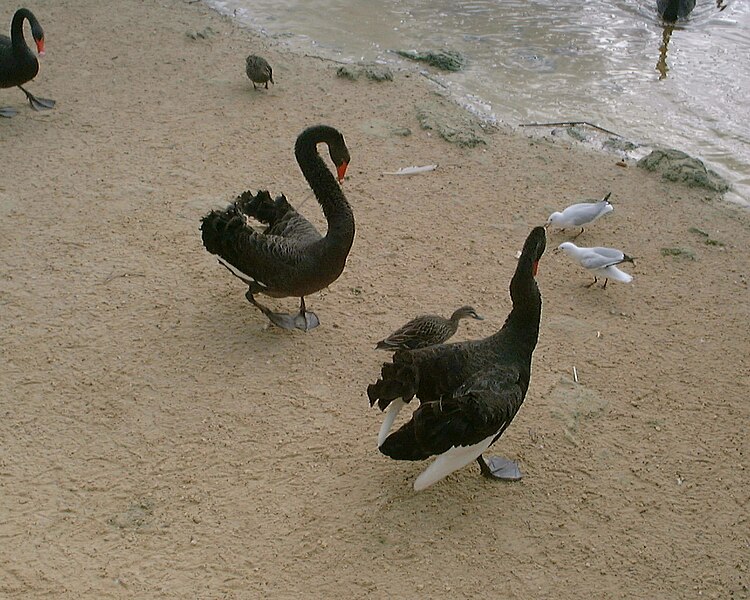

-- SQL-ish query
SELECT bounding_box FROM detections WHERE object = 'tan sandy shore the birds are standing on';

[0,0,750,600]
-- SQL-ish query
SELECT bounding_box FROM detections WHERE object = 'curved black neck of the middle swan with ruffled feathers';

[294,126,354,252]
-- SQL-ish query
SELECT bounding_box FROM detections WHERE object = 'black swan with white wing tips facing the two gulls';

[367,227,546,490]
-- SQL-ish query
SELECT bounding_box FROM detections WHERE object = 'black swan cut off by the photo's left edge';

[0,8,55,117]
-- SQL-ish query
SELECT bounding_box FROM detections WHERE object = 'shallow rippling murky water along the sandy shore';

[209,0,750,202]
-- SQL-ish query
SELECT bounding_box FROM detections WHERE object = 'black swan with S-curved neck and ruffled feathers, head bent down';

[201,125,354,331]
